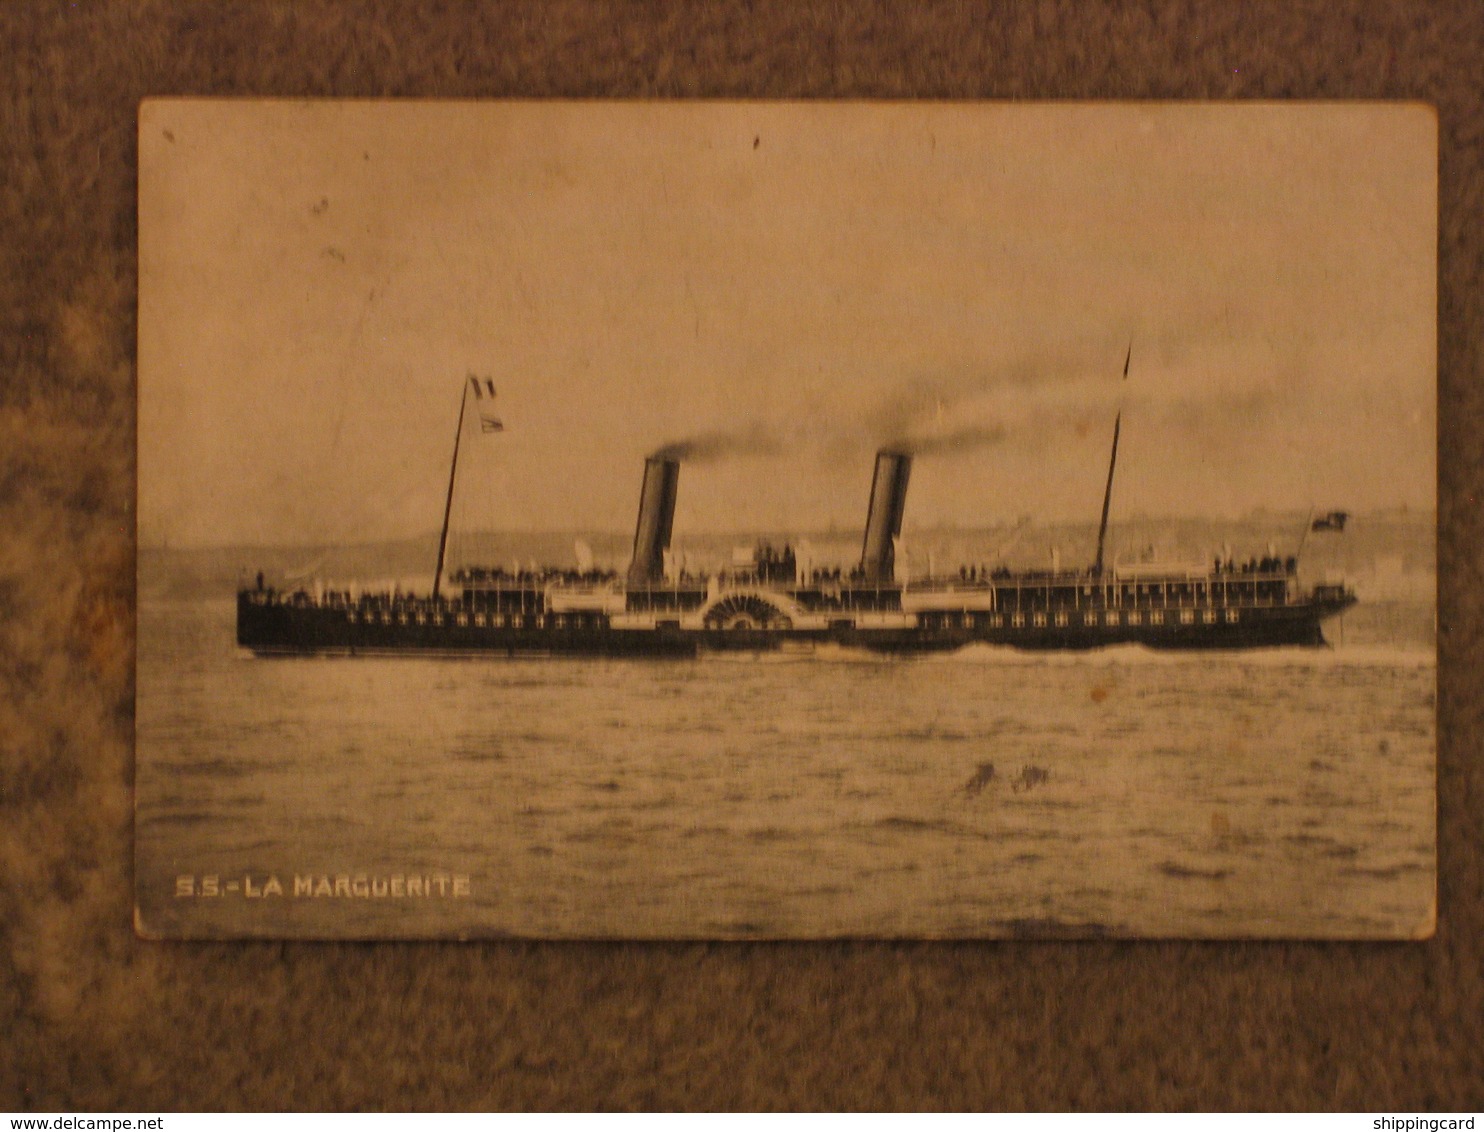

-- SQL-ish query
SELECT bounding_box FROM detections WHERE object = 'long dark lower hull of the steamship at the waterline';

[237,593,1353,657]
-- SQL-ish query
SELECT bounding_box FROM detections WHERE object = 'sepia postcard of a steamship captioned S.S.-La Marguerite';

[137,99,1437,939]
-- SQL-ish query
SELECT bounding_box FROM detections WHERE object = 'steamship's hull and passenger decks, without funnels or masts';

[237,574,1355,656]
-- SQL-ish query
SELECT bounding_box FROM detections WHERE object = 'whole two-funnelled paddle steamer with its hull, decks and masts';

[237,376,1355,656]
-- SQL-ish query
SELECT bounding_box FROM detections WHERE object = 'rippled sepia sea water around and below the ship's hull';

[137,601,1435,938]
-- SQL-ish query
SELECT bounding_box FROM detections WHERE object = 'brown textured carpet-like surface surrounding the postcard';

[0,0,1484,1110]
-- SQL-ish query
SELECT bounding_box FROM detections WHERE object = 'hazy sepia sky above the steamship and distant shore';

[138,99,1437,547]
